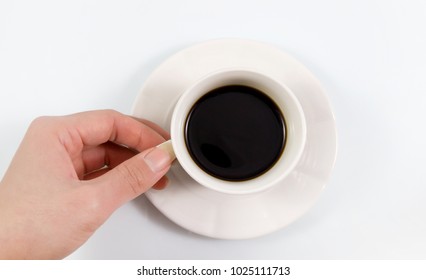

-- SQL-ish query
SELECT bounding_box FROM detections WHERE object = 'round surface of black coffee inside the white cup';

[185,85,285,181]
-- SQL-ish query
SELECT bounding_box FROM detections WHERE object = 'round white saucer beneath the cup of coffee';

[133,39,336,239]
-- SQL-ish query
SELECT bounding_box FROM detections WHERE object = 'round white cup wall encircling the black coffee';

[170,68,306,194]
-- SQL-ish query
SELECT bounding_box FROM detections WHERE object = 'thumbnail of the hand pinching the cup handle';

[144,140,175,172]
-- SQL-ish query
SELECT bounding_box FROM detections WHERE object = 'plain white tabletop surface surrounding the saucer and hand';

[0,0,426,259]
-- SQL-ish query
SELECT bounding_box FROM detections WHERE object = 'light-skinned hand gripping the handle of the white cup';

[0,110,174,259]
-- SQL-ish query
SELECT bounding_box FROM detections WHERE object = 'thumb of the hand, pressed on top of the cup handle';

[97,140,175,207]
